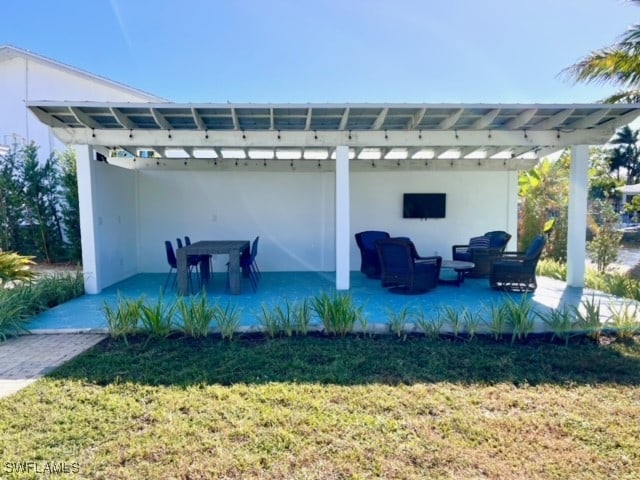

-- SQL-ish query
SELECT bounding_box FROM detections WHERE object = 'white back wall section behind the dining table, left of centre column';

[139,171,335,272]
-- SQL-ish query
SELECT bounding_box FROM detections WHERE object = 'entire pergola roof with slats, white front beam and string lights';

[28,101,640,169]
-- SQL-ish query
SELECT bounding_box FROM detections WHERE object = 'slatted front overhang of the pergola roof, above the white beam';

[29,102,640,130]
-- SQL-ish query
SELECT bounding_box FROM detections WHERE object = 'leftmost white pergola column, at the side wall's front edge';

[74,145,101,294]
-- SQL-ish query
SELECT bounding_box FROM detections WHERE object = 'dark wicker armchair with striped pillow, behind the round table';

[451,230,511,278]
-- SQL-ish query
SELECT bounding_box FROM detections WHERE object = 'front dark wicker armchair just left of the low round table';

[376,238,442,294]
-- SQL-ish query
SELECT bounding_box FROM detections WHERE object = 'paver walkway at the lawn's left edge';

[0,333,106,397]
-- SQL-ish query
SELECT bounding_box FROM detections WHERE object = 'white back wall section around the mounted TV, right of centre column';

[351,171,517,264]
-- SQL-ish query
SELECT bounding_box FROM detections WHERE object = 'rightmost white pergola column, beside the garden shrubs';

[567,145,589,287]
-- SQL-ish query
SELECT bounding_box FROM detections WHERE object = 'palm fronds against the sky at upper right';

[563,0,640,103]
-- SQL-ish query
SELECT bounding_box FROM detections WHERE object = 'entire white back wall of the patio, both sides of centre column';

[134,171,517,272]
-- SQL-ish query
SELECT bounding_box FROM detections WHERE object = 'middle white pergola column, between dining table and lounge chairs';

[336,145,351,290]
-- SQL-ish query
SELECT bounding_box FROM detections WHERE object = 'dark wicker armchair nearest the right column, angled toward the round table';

[489,235,546,292]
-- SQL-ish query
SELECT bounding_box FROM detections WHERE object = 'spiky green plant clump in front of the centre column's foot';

[311,292,363,336]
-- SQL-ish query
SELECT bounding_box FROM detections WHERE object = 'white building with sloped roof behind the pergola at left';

[0,45,163,158]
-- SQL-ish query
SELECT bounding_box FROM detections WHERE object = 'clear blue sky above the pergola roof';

[0,0,640,103]
